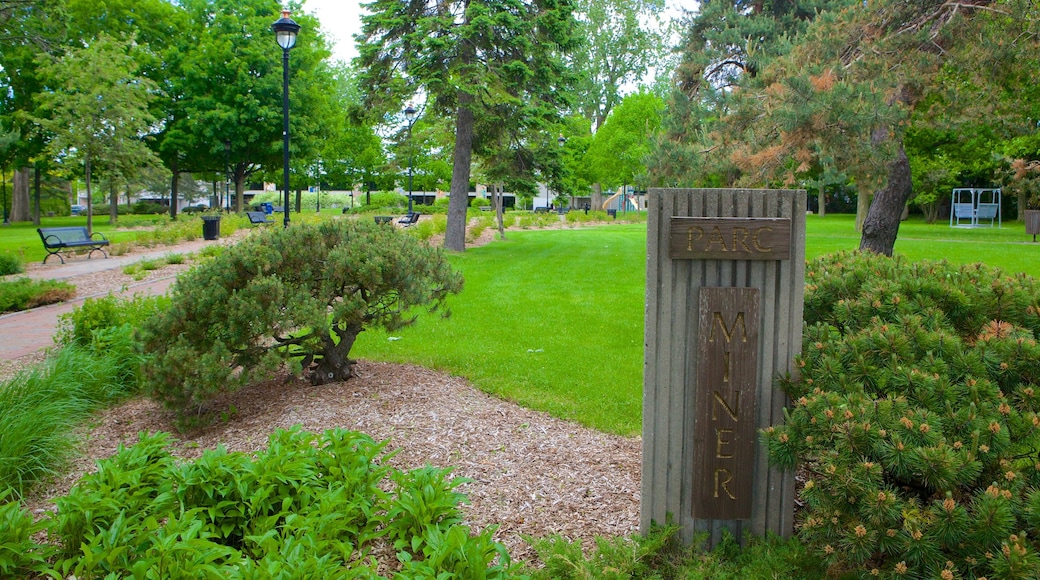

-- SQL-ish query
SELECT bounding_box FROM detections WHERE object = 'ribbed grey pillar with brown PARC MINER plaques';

[642,189,805,547]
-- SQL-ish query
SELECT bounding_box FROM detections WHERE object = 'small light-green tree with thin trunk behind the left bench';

[37,34,155,231]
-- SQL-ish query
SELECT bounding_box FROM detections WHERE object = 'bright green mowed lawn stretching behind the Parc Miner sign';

[352,215,1040,436]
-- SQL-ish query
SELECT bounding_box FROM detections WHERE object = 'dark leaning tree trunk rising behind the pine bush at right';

[859,142,913,256]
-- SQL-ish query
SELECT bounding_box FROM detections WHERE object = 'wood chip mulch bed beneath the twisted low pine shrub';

[27,361,642,561]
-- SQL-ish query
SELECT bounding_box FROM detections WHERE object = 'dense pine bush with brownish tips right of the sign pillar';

[764,254,1040,578]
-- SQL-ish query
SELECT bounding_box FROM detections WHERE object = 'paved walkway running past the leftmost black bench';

[0,240,219,361]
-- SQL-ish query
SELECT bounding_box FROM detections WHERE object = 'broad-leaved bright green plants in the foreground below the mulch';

[36,427,513,579]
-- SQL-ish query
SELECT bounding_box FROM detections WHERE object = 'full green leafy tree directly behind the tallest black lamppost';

[159,0,335,210]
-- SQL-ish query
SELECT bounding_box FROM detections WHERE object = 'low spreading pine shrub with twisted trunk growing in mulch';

[141,219,462,414]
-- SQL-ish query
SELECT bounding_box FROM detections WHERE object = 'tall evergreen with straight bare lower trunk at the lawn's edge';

[357,0,578,252]
